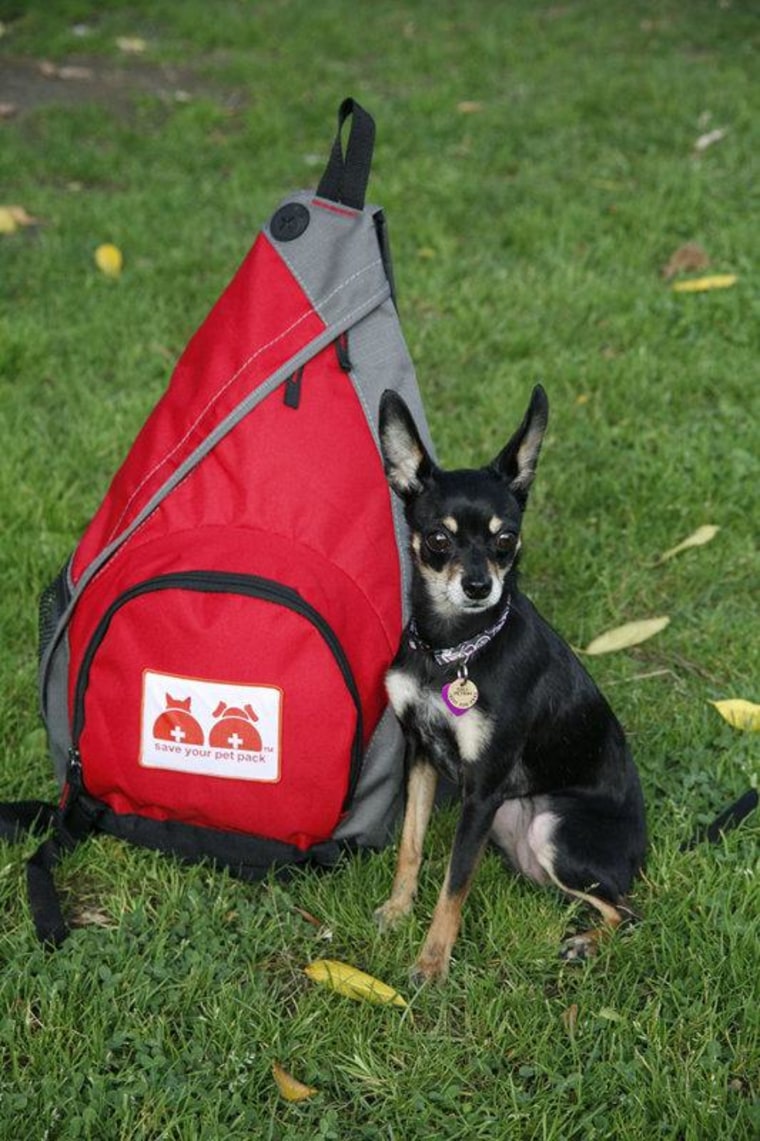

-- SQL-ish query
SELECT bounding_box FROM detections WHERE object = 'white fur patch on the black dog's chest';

[386,670,491,777]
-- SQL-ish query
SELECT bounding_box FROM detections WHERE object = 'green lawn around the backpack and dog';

[0,0,760,1141]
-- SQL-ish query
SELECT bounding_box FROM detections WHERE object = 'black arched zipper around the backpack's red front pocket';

[72,571,364,808]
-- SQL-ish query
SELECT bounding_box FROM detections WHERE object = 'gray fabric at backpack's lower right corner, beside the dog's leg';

[335,707,405,848]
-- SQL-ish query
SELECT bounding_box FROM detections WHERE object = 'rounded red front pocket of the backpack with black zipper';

[72,571,363,849]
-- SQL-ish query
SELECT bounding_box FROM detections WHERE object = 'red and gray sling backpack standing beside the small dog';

[0,99,422,944]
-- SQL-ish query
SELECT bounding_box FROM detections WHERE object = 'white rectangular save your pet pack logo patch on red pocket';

[139,670,282,783]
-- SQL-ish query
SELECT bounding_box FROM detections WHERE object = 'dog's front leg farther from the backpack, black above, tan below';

[412,794,499,984]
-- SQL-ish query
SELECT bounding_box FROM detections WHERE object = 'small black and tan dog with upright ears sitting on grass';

[375,386,646,981]
